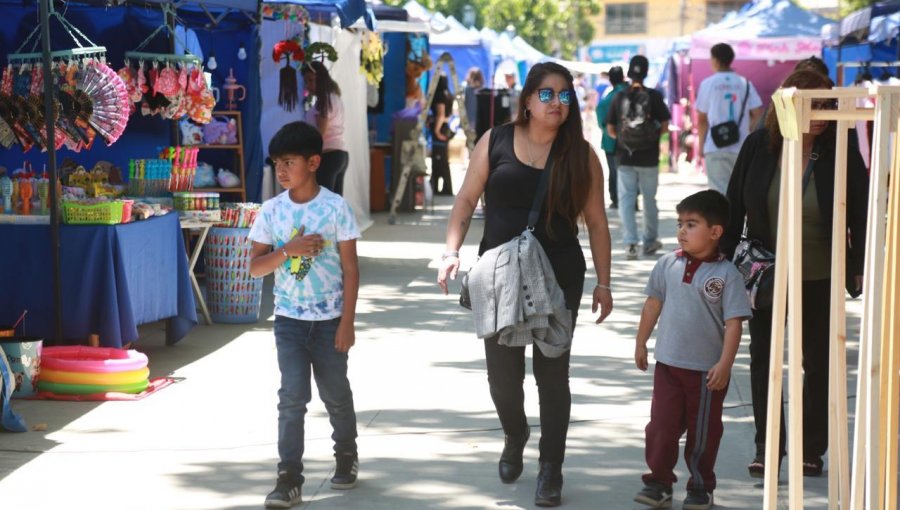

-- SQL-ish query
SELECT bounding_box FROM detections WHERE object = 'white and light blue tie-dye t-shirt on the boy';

[249,187,360,321]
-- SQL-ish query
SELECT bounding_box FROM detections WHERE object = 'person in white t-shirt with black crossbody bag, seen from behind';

[696,43,763,193]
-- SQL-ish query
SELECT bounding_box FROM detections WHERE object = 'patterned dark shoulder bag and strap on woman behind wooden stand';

[731,145,819,310]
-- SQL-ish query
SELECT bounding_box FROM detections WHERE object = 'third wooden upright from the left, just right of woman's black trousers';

[828,99,851,510]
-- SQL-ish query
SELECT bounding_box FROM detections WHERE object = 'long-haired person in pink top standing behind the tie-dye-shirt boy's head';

[301,60,350,195]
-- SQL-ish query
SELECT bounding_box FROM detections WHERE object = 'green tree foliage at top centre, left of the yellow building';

[385,0,601,58]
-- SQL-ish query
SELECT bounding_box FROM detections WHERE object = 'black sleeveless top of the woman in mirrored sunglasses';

[478,124,585,309]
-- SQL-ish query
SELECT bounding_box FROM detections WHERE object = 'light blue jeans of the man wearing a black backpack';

[616,165,659,246]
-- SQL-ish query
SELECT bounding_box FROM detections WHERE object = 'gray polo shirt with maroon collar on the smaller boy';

[644,250,752,372]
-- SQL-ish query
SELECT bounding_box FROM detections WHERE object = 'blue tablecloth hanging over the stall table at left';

[0,214,197,347]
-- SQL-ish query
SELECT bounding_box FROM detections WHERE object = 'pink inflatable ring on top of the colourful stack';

[41,345,147,374]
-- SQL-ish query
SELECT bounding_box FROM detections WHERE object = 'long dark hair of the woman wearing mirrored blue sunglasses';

[514,62,591,232]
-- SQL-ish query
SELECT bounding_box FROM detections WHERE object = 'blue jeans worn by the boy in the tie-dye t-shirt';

[275,316,356,484]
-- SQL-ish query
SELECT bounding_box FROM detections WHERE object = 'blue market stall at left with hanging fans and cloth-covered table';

[0,2,261,347]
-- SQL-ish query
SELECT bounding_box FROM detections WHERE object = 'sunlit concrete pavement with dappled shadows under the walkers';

[0,169,860,510]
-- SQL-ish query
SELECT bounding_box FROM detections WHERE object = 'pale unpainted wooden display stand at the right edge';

[763,86,900,510]
